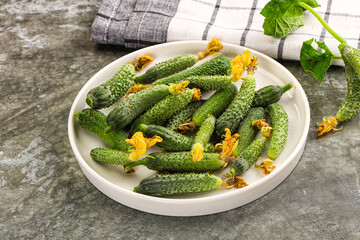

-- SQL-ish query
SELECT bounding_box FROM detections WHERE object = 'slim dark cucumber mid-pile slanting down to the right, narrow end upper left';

[139,124,194,152]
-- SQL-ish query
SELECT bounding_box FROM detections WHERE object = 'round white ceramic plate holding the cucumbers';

[68,41,310,216]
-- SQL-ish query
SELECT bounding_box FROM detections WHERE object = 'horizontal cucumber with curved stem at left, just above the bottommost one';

[125,152,224,173]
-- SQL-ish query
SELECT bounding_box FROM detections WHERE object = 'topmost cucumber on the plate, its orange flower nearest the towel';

[135,54,199,83]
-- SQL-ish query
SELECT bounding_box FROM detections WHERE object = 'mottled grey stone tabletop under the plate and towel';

[0,0,360,240]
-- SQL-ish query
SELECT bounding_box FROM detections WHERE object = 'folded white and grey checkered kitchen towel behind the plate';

[92,0,360,63]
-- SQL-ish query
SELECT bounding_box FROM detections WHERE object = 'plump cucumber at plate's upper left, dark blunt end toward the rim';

[86,64,135,109]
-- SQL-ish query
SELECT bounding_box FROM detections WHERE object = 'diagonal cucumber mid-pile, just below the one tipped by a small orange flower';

[130,89,194,134]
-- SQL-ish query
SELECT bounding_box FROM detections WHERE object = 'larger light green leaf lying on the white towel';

[260,0,320,38]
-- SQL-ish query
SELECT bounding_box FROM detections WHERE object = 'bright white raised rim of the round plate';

[67,40,310,216]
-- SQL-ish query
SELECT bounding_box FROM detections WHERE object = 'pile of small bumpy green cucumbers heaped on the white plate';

[75,42,292,196]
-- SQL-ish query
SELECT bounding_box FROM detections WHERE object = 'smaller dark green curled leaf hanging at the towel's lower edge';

[300,38,334,82]
